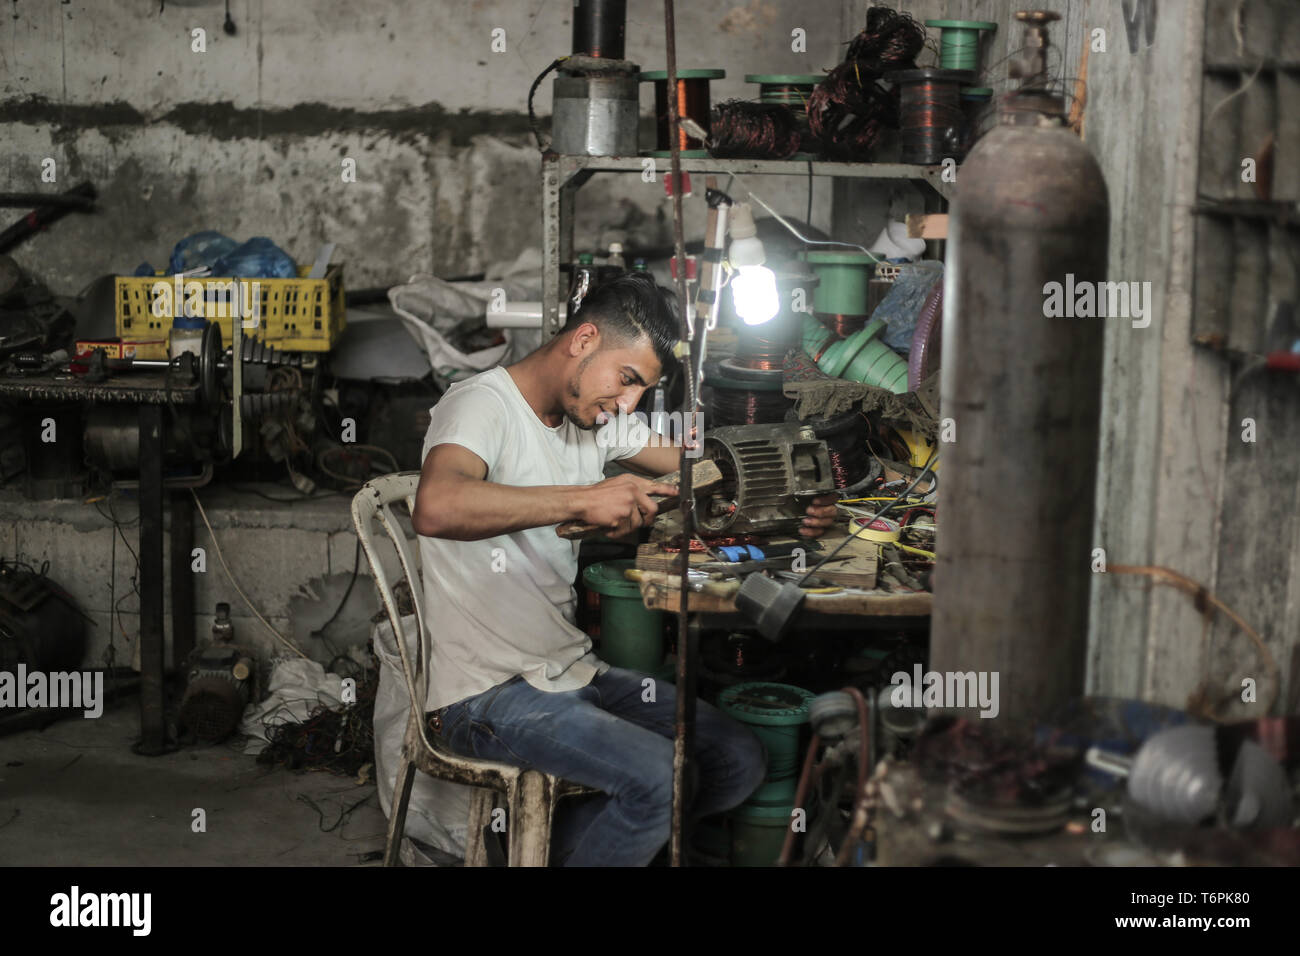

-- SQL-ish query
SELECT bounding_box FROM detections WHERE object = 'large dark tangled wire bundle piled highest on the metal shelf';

[805,7,926,160]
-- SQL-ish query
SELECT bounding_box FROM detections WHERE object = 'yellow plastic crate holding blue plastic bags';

[116,263,347,359]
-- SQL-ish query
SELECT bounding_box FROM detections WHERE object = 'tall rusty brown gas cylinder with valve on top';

[931,12,1110,721]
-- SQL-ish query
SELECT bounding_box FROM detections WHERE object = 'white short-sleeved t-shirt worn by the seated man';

[420,368,645,710]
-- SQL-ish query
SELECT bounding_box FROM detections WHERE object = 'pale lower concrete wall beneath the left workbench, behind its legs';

[0,485,398,667]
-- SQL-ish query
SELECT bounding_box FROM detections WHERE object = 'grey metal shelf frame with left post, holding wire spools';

[542,152,954,338]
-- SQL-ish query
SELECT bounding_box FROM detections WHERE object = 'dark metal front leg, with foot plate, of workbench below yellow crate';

[135,405,168,757]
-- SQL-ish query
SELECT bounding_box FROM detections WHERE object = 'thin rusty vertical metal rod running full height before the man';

[663,0,703,866]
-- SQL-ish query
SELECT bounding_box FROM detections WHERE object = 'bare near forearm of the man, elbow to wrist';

[412,479,581,541]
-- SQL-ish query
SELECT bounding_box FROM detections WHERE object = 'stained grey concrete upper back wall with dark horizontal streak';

[0,0,841,294]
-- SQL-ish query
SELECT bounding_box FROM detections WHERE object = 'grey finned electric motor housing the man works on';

[697,424,835,536]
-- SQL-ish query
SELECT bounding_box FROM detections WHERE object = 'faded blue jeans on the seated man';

[442,667,767,866]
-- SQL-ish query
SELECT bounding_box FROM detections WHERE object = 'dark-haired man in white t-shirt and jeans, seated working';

[413,273,835,866]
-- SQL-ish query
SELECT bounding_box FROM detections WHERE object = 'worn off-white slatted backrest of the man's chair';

[352,471,429,726]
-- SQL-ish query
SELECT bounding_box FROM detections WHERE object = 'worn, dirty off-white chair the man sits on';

[352,471,593,866]
